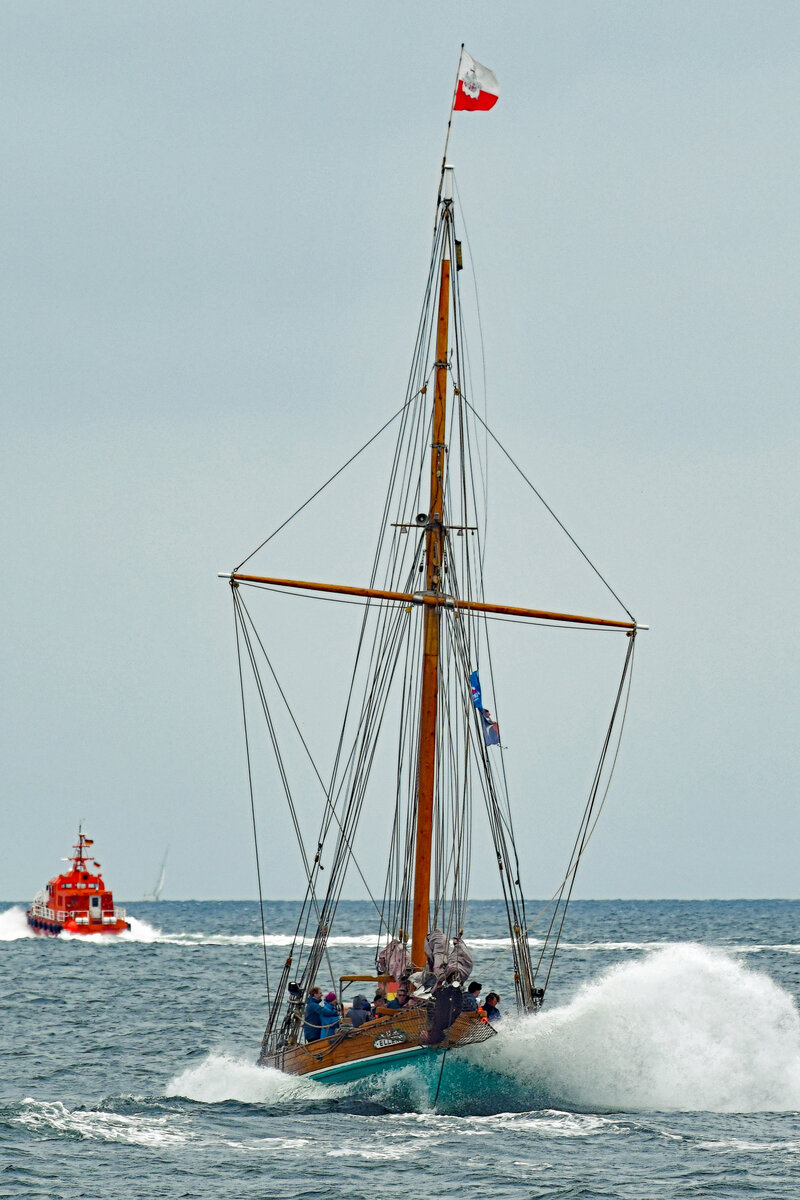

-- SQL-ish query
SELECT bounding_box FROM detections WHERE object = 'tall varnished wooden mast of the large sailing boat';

[411,167,452,970]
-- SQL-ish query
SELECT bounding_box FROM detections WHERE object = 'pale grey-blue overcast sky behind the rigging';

[0,0,800,899]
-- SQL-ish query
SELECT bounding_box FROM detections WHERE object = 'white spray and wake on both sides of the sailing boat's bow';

[167,944,800,1116]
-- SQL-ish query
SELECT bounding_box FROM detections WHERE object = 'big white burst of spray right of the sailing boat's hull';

[474,944,800,1112]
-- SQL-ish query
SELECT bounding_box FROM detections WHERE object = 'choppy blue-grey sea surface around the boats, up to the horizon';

[0,900,800,1200]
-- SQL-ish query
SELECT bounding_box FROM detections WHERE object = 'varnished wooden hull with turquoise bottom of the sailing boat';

[259,1008,494,1082]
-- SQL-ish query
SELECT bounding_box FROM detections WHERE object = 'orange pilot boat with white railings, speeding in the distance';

[28,827,131,936]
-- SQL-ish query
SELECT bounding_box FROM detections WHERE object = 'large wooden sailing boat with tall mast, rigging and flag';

[222,56,643,1082]
